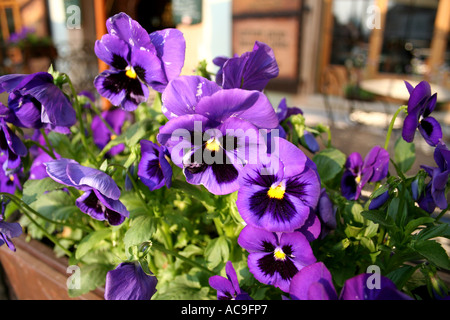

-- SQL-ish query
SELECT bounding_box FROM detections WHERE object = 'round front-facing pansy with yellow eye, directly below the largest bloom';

[236,138,320,232]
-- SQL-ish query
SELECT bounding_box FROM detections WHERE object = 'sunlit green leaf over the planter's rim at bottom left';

[68,264,111,298]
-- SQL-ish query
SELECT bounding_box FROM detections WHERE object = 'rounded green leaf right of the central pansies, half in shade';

[313,148,346,182]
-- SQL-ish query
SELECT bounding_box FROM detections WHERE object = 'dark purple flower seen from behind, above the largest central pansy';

[215,41,279,91]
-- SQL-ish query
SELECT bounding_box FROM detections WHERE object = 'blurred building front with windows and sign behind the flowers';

[0,0,450,138]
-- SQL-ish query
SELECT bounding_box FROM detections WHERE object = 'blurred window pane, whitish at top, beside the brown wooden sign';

[330,0,374,67]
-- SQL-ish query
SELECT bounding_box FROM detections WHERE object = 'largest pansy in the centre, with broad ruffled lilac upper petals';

[158,76,278,194]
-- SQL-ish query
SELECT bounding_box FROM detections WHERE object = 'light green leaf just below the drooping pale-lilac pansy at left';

[123,216,156,248]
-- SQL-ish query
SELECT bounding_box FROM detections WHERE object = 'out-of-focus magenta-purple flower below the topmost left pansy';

[91,109,127,156]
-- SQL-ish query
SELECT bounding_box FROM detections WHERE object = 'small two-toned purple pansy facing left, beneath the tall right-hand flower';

[341,146,389,200]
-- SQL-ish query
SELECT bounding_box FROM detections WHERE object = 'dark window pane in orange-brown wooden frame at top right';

[379,0,439,75]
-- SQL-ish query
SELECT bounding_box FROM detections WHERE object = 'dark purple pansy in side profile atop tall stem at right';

[402,81,442,146]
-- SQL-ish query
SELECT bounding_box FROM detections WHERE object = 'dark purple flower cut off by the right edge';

[422,142,450,210]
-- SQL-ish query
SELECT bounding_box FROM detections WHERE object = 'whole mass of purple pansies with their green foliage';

[0,13,450,300]
